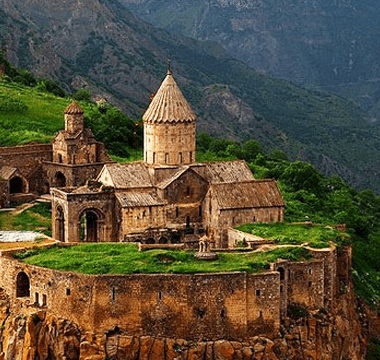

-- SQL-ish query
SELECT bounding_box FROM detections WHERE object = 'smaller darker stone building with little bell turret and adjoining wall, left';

[0,102,110,207]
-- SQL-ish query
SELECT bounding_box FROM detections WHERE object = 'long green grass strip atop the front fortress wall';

[16,243,311,274]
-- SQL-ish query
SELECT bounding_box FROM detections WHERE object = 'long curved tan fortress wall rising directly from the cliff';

[0,250,338,340]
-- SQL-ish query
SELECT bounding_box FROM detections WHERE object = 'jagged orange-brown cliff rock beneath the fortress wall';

[0,286,366,360]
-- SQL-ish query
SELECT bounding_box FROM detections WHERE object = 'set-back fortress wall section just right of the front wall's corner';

[288,260,324,310]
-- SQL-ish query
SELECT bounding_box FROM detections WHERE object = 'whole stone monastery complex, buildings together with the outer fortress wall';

[0,70,351,340]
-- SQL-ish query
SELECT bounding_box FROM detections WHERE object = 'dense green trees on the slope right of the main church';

[197,135,380,309]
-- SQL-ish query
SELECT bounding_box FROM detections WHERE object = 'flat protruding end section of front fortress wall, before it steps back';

[246,272,280,337]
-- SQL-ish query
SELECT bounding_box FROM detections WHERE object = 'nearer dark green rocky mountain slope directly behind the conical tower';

[0,0,380,190]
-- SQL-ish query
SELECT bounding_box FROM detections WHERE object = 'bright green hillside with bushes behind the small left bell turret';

[0,51,142,157]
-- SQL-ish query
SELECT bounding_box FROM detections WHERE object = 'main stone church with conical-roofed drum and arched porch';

[51,70,284,248]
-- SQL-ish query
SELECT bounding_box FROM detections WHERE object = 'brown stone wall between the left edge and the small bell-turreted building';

[0,144,53,192]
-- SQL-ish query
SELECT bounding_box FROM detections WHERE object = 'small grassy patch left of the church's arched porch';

[0,203,51,236]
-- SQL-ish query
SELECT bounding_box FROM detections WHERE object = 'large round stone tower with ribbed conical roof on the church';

[143,68,196,165]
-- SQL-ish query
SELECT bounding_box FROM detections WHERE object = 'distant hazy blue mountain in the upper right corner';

[121,0,380,120]
